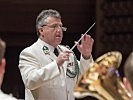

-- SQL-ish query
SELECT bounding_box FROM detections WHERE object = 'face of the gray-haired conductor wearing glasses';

[39,17,63,47]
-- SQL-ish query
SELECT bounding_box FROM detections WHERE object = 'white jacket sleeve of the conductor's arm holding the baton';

[19,51,60,90]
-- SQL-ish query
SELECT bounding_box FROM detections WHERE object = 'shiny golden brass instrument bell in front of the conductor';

[74,51,131,100]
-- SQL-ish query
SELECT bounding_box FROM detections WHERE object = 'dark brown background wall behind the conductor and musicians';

[0,0,133,98]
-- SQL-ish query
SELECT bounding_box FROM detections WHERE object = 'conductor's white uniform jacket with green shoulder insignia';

[19,39,93,100]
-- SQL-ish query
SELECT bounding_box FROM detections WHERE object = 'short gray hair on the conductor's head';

[36,9,61,36]
